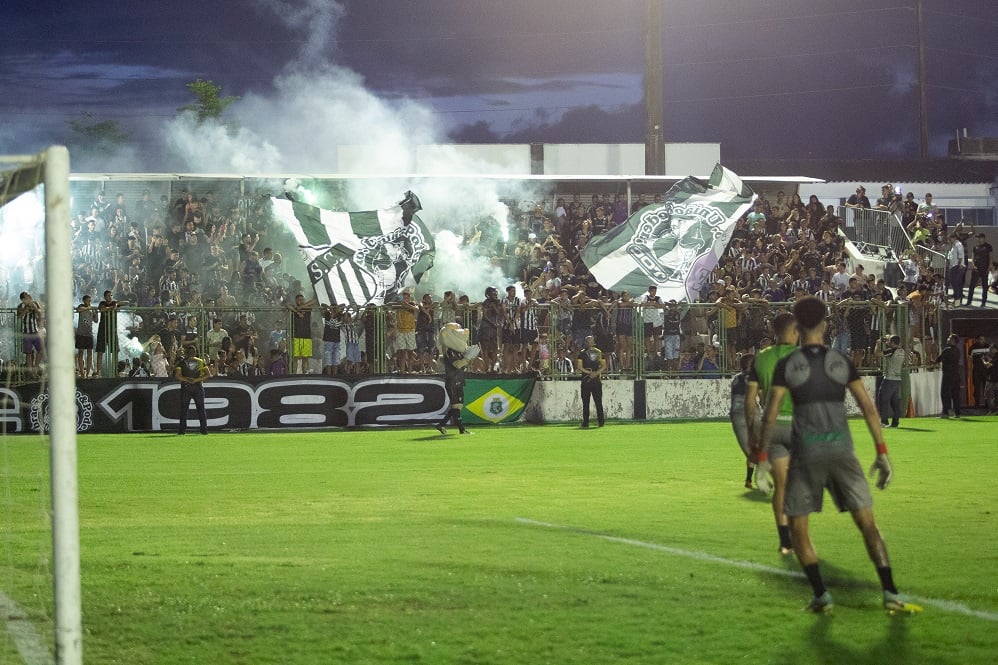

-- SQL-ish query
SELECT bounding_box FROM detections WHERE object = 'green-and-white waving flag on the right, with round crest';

[582,164,755,302]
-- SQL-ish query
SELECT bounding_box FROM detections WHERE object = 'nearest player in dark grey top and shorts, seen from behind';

[762,296,922,614]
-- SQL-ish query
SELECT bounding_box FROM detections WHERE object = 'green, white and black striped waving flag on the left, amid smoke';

[271,192,434,305]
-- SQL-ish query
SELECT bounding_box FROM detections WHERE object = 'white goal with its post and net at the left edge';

[0,146,83,665]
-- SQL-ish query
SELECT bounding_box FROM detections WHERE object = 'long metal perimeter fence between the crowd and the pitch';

[0,299,941,381]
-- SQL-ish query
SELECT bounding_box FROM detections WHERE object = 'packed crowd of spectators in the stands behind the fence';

[5,185,996,376]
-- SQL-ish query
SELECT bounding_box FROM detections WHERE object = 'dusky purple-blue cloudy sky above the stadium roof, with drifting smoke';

[0,0,998,171]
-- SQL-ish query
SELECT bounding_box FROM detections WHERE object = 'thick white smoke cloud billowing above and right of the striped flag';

[166,0,540,301]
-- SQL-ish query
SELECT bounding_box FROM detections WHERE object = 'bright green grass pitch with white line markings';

[0,418,998,665]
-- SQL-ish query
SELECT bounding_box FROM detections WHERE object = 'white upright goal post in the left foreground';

[44,146,83,665]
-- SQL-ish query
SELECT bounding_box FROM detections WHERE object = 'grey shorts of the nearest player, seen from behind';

[783,451,873,517]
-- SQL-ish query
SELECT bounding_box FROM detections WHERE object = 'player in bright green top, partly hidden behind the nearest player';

[745,312,797,554]
